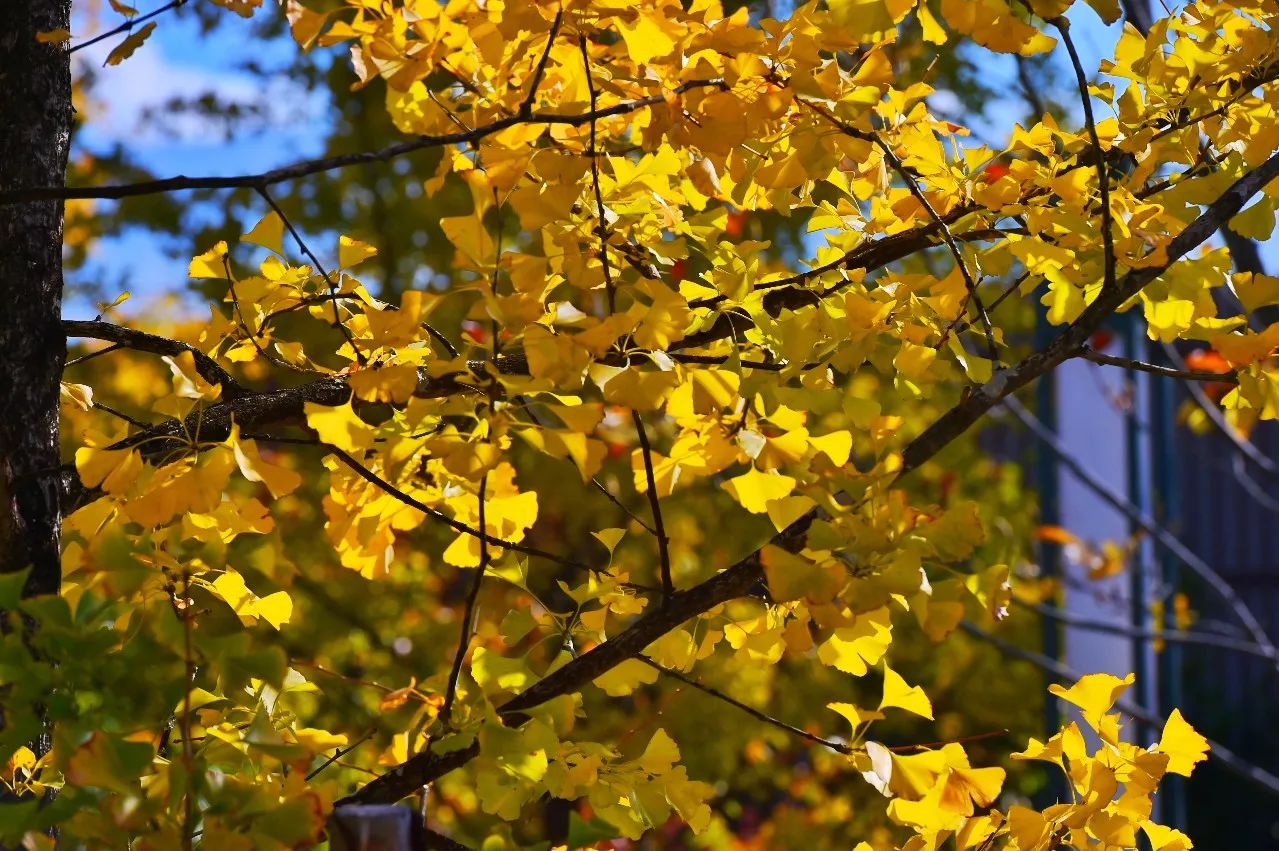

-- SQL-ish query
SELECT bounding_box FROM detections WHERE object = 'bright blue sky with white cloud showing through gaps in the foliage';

[64,4,1279,317]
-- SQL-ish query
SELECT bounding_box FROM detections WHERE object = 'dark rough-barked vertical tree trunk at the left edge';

[0,0,72,596]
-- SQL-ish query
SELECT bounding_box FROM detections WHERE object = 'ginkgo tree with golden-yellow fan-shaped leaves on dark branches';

[0,0,1279,851]
